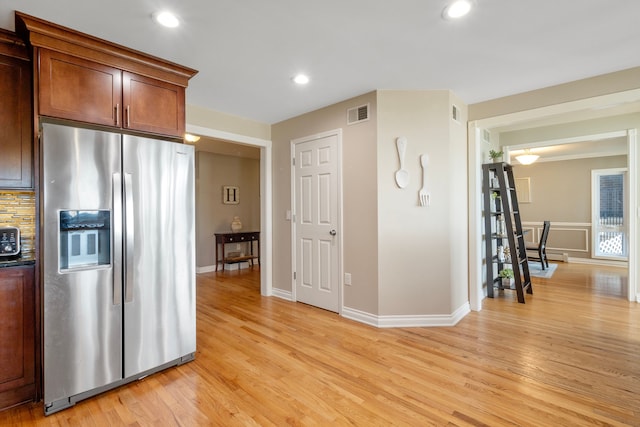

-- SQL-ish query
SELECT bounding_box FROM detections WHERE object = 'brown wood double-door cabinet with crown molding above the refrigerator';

[16,12,197,138]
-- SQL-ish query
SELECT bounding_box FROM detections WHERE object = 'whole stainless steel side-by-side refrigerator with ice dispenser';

[41,123,196,414]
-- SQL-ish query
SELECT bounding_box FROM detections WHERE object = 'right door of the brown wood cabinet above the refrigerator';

[122,72,185,138]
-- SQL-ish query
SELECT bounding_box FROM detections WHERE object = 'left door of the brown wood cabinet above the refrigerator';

[38,49,122,126]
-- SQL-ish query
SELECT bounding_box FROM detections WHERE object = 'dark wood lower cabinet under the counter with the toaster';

[0,265,36,410]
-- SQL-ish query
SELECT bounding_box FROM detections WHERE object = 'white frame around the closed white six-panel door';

[289,129,344,315]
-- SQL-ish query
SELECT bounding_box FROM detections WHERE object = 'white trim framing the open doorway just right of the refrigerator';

[187,124,273,296]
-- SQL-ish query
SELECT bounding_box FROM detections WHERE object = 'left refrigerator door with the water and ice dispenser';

[41,123,122,411]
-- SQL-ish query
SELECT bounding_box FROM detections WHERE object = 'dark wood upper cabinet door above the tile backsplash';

[0,55,33,188]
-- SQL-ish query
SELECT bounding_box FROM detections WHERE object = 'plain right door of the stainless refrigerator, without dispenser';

[122,135,196,378]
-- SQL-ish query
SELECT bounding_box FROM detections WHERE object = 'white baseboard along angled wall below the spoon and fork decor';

[342,302,471,328]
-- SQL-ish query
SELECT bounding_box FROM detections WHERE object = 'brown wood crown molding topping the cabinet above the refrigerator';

[15,11,198,88]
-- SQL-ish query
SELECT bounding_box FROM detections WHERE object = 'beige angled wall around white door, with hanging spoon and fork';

[272,91,468,316]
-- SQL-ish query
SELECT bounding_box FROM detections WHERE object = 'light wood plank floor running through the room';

[0,264,640,426]
